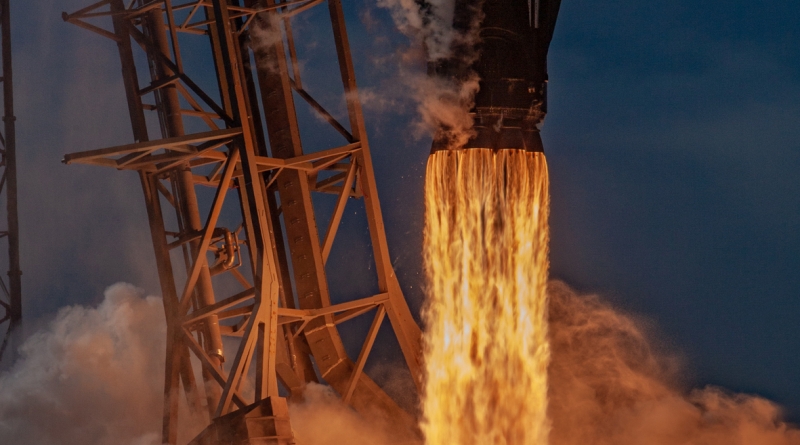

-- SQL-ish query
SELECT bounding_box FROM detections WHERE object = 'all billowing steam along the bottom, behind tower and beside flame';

[0,282,800,445]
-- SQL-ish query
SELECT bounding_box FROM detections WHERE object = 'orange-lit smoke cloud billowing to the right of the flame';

[548,281,800,445]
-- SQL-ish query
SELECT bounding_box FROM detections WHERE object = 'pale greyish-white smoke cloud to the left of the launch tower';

[0,284,166,445]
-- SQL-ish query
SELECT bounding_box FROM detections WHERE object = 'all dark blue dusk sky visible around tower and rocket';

[7,0,800,421]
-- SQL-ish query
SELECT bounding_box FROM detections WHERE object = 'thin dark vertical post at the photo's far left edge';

[0,0,22,354]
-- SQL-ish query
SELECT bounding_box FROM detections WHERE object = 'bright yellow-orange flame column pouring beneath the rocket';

[422,149,550,445]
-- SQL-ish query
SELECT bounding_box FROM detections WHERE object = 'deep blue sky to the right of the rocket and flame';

[543,0,800,419]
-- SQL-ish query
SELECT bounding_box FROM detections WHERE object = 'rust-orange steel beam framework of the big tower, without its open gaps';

[65,0,428,438]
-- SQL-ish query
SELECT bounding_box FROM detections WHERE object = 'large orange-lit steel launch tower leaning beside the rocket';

[63,0,422,444]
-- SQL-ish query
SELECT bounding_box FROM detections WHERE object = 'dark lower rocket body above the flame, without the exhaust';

[428,0,561,152]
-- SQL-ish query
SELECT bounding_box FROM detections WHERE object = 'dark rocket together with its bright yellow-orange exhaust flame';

[422,0,560,445]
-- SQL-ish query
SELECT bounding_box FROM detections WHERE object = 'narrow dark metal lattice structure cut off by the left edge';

[0,0,22,366]
